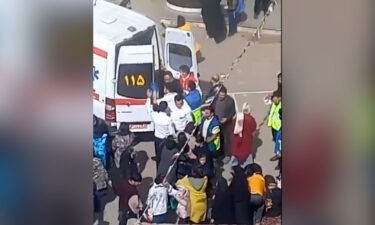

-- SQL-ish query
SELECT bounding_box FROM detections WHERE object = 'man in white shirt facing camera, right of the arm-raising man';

[170,95,193,132]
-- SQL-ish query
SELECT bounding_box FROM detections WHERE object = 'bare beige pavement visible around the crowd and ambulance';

[98,0,281,225]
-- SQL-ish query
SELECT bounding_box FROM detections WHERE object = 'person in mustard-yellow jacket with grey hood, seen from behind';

[176,168,208,223]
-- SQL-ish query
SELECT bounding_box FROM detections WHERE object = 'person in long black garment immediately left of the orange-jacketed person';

[229,166,253,224]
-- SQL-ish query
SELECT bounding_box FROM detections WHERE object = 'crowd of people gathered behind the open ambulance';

[93,69,281,225]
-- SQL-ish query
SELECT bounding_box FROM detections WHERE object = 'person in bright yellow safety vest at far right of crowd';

[267,91,281,141]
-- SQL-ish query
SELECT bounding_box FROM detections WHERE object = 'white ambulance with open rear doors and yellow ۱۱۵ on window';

[93,0,197,132]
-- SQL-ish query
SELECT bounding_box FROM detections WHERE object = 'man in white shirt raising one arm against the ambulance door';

[146,91,176,167]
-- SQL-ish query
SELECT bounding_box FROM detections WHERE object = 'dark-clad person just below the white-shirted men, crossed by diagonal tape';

[157,136,179,185]
